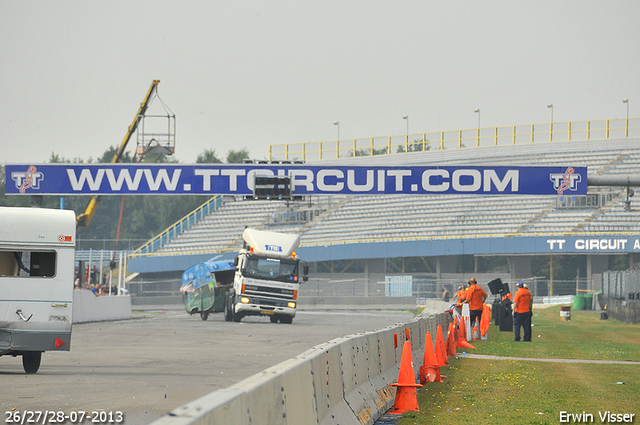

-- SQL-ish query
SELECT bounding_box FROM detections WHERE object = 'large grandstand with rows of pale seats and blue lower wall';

[130,124,640,300]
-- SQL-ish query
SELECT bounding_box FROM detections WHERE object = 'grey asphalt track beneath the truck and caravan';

[0,310,413,425]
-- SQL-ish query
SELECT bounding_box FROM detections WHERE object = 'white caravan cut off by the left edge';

[0,207,76,373]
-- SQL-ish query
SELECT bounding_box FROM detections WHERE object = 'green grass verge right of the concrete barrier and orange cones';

[398,306,640,425]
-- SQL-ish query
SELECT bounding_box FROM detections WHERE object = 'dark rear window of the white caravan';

[0,249,56,277]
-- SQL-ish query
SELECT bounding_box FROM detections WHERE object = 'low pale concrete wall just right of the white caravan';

[73,289,133,323]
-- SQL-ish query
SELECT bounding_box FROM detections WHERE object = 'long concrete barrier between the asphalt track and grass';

[153,313,451,425]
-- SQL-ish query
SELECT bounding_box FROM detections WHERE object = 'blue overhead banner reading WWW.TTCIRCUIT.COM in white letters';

[5,164,587,195]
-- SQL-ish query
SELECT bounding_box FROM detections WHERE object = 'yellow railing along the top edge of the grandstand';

[269,118,640,161]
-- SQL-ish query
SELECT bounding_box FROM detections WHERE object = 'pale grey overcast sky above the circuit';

[0,0,640,165]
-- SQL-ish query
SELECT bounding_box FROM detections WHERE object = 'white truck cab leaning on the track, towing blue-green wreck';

[224,228,309,323]
